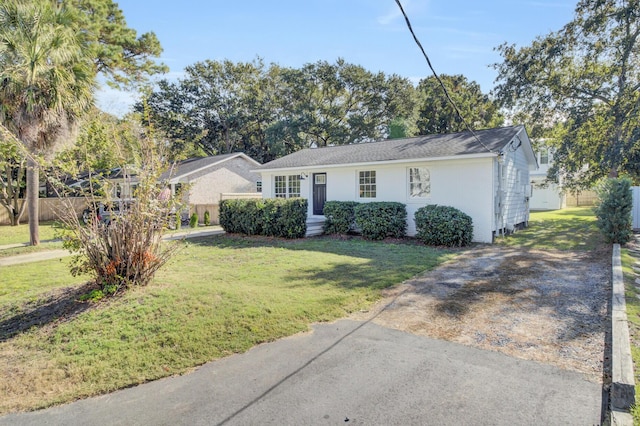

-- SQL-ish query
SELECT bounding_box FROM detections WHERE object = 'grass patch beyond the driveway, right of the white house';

[496,207,604,251]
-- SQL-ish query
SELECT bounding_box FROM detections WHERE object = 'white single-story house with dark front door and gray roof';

[256,126,537,243]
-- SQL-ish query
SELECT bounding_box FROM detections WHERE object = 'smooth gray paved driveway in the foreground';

[0,320,602,425]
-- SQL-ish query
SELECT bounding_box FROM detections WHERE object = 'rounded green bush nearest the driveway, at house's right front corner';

[414,204,473,247]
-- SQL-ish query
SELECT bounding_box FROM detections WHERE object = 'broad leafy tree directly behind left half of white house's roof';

[282,59,413,147]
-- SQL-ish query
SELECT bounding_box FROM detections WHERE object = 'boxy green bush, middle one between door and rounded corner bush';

[354,202,407,240]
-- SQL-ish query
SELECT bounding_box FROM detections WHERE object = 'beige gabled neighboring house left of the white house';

[160,152,261,223]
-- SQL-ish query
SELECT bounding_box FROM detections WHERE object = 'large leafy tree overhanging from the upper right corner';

[495,0,640,189]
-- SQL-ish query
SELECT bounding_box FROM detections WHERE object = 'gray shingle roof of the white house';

[258,125,523,170]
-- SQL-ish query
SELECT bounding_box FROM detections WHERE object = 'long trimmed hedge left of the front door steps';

[220,198,308,238]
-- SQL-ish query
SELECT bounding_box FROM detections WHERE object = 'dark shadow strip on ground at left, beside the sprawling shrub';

[0,283,96,342]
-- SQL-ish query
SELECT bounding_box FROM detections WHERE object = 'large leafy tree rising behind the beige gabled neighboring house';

[142,59,270,161]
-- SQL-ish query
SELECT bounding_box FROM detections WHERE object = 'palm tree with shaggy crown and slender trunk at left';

[0,0,96,245]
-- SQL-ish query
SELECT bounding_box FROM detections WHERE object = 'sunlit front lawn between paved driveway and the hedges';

[0,236,452,414]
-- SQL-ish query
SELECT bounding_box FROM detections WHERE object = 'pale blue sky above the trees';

[98,0,576,115]
